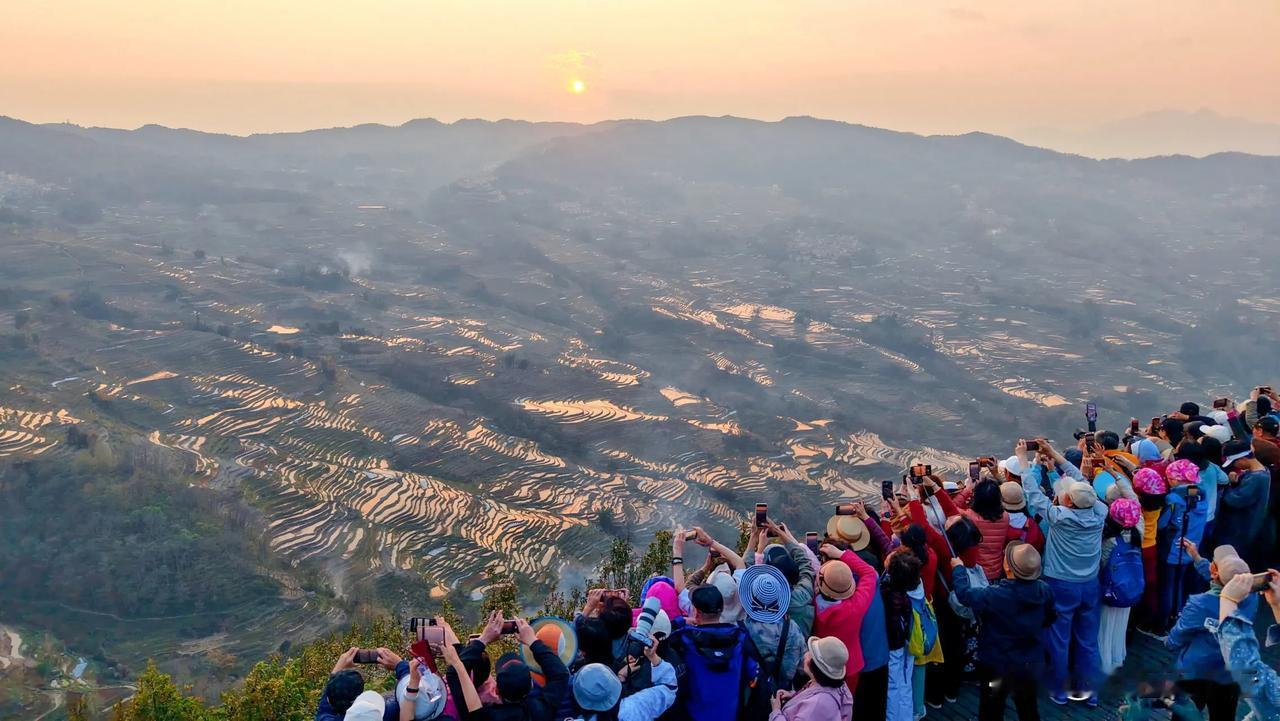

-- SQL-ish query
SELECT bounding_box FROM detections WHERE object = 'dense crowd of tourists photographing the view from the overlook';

[316,387,1280,721]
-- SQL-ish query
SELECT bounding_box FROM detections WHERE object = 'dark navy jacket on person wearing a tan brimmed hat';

[951,569,1057,675]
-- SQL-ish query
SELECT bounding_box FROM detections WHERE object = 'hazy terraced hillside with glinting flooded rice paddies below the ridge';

[0,118,1280,717]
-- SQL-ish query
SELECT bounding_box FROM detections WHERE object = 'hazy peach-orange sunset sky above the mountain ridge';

[0,0,1280,133]
